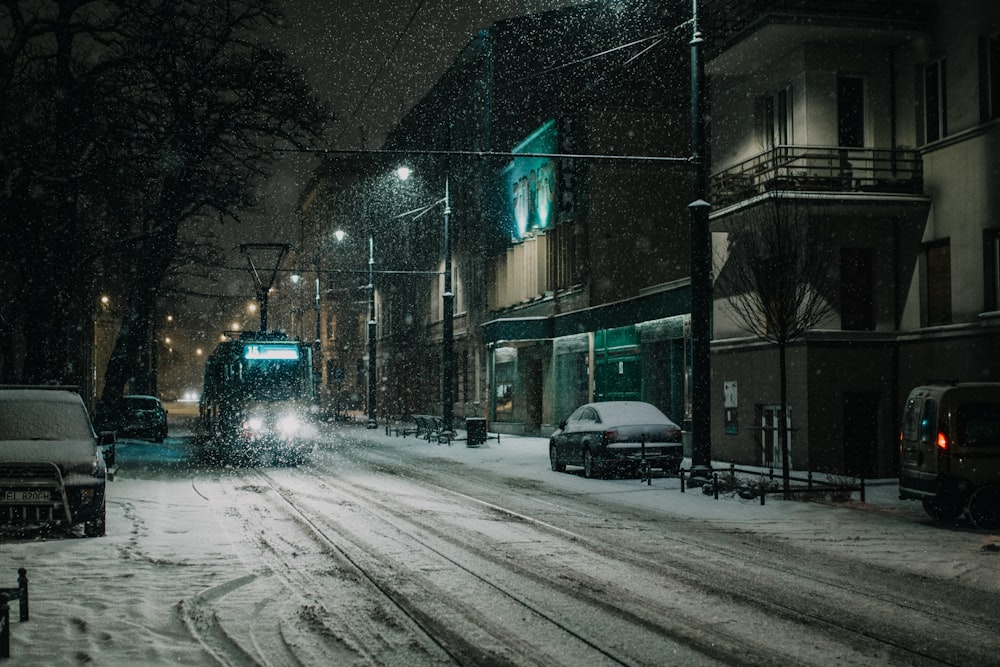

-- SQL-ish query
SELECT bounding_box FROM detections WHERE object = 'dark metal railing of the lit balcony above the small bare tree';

[709,146,923,209]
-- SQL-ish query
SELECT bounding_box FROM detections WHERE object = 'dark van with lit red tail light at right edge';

[899,382,1000,527]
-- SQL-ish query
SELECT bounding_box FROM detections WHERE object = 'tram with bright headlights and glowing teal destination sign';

[196,331,316,465]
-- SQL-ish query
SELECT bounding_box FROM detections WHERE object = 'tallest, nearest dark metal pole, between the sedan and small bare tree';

[688,0,712,483]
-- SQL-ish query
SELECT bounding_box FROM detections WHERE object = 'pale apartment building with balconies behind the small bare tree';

[705,0,1000,477]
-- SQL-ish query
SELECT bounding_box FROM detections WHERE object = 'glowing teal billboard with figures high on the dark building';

[503,120,557,239]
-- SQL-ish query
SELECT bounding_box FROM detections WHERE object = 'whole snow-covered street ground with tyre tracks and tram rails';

[0,425,1000,666]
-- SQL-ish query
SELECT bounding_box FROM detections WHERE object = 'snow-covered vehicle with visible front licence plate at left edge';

[0,387,114,537]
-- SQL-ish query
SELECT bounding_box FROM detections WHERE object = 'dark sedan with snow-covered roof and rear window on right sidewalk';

[549,401,684,477]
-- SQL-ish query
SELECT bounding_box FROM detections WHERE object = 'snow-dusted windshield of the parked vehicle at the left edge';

[0,400,93,440]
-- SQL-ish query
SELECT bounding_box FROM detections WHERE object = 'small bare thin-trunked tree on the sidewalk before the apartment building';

[716,199,835,499]
